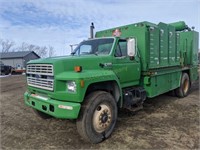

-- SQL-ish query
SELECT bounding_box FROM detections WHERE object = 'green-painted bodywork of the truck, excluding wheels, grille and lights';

[24,22,198,119]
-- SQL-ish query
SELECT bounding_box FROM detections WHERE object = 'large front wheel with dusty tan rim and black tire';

[76,91,117,143]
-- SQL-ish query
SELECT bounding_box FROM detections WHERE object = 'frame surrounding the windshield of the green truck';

[71,37,116,56]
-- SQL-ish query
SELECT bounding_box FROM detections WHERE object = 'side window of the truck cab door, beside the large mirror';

[115,40,127,57]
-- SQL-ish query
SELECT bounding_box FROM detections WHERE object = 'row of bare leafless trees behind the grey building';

[0,39,56,58]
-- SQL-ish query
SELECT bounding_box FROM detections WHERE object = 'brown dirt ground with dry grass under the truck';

[0,76,200,149]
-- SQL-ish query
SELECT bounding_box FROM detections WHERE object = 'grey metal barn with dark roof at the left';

[0,51,40,69]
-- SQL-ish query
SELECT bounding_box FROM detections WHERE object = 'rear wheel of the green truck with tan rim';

[175,73,190,98]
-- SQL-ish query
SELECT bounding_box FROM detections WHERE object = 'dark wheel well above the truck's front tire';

[85,81,121,102]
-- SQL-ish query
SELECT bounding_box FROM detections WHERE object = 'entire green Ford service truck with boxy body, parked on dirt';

[24,21,199,143]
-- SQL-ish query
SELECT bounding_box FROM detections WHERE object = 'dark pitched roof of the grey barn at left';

[0,51,40,59]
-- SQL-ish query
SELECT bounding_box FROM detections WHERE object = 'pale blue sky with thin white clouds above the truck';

[0,0,200,55]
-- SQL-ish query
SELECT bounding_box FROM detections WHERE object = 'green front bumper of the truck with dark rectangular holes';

[24,92,81,119]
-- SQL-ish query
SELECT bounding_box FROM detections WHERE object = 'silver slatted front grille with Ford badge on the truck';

[26,64,54,91]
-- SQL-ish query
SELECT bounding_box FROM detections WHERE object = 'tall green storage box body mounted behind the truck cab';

[95,21,198,72]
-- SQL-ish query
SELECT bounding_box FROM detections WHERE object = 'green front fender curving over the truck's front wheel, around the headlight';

[55,70,122,102]
